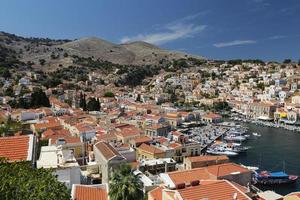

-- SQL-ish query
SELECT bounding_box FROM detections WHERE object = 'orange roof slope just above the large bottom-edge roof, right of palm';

[168,168,214,185]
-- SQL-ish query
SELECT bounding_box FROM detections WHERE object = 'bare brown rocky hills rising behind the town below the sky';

[0,32,203,71]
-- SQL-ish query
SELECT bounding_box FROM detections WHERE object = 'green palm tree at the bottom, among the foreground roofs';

[109,164,144,200]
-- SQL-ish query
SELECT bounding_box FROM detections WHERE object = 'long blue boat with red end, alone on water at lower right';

[253,171,299,185]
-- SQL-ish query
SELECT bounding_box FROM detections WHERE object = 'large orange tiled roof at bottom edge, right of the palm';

[178,180,250,200]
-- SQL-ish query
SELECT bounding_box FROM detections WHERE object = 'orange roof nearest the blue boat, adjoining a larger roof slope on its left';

[206,163,250,177]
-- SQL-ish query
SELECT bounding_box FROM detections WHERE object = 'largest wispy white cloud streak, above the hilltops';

[121,23,206,45]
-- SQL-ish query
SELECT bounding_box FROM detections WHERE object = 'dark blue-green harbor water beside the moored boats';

[231,123,300,195]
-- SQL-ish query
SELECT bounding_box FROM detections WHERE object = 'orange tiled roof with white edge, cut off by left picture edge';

[0,135,33,161]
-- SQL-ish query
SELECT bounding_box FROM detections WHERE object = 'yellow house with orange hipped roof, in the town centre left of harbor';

[136,143,166,161]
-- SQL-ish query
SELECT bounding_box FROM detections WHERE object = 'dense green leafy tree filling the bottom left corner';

[0,159,70,200]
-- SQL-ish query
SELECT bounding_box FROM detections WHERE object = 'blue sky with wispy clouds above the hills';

[0,0,300,61]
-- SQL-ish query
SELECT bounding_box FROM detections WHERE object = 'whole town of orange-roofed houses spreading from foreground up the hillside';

[0,48,300,200]
